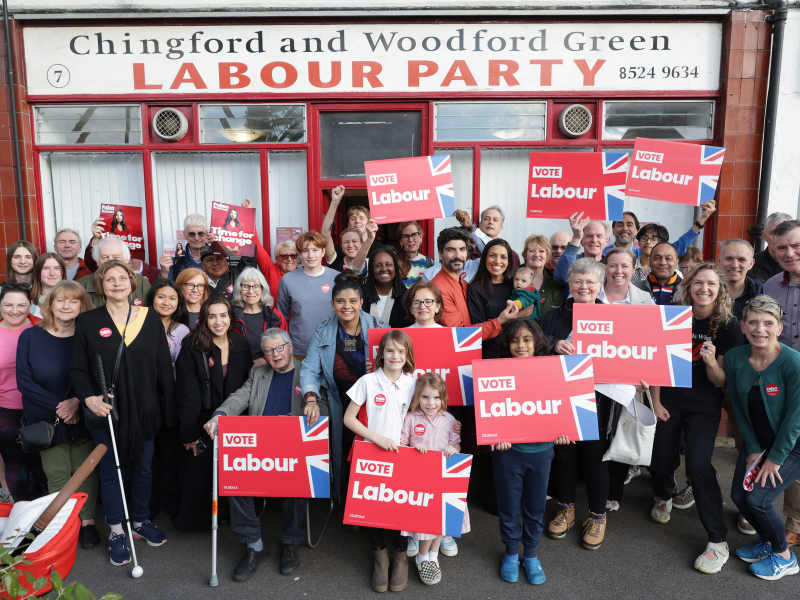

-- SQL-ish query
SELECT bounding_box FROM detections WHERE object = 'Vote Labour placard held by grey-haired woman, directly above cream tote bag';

[572,304,692,387]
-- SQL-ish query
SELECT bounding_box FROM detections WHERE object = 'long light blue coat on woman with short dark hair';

[300,310,389,500]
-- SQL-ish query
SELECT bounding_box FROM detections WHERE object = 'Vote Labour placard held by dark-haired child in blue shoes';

[472,354,600,446]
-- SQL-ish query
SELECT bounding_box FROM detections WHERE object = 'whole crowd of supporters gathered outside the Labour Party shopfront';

[0,191,800,592]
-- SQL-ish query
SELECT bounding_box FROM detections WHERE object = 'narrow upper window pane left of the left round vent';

[35,104,142,145]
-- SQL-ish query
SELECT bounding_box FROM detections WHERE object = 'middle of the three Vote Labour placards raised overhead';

[528,152,628,221]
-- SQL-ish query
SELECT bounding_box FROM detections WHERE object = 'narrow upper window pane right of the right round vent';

[603,101,714,141]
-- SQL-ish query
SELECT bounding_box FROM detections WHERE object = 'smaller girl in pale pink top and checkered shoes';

[400,373,469,585]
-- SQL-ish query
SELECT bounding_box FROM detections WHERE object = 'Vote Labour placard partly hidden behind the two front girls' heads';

[369,327,483,406]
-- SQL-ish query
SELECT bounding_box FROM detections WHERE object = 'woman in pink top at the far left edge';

[0,283,38,501]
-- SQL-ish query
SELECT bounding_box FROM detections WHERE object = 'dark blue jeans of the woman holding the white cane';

[91,429,154,525]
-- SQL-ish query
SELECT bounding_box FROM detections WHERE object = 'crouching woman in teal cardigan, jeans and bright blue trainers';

[725,296,800,580]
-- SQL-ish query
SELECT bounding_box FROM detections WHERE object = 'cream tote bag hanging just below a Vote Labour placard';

[603,390,656,466]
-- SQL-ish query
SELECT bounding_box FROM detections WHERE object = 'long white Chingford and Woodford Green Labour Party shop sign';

[24,23,722,97]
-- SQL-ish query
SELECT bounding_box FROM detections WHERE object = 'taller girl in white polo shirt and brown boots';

[344,330,415,592]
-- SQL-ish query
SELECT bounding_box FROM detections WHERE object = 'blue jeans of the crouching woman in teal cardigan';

[731,443,800,552]
